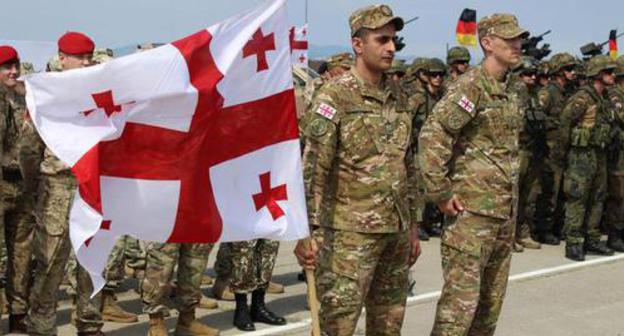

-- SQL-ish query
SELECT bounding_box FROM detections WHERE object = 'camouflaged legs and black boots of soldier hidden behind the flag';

[227,239,286,331]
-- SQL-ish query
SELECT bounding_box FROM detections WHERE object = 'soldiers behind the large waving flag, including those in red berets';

[0,32,286,336]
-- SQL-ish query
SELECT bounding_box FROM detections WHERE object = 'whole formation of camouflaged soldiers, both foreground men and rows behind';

[0,5,624,336]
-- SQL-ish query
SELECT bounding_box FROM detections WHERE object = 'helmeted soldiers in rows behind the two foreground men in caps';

[305,37,624,261]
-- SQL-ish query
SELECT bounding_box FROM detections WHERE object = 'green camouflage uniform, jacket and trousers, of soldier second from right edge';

[561,85,613,244]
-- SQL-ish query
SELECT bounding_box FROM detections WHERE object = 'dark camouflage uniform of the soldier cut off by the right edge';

[605,86,624,230]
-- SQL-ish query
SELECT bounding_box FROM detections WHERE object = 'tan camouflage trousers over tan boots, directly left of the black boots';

[141,242,213,314]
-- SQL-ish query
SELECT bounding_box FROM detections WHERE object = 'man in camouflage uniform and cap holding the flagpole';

[295,5,420,335]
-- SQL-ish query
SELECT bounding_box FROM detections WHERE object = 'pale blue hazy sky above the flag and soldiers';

[0,0,624,58]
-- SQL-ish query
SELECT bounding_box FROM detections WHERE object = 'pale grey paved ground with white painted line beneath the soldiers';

[2,239,624,336]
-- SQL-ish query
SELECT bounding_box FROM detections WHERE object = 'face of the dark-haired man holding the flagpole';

[352,24,396,72]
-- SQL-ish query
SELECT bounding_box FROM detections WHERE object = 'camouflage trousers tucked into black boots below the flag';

[226,239,279,294]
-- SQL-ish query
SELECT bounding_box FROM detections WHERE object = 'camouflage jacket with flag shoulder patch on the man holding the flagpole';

[303,70,415,233]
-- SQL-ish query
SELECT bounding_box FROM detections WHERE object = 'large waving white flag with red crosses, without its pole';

[26,0,308,290]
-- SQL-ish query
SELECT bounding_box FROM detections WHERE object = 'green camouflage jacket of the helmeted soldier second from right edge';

[561,85,615,150]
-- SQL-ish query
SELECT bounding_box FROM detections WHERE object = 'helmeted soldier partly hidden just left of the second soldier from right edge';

[534,53,578,245]
